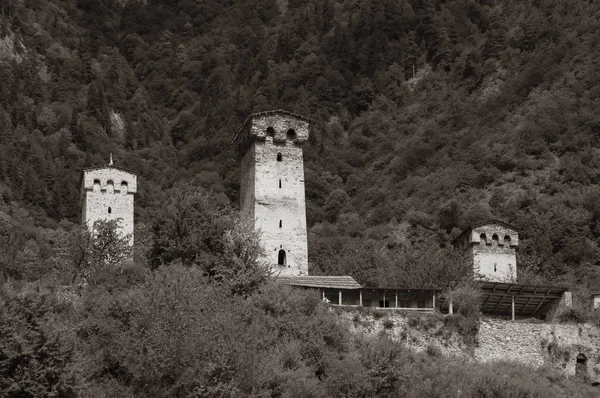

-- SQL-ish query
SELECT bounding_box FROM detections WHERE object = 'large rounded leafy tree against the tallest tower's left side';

[149,184,269,295]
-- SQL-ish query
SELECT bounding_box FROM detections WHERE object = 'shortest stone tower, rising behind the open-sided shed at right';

[453,220,519,282]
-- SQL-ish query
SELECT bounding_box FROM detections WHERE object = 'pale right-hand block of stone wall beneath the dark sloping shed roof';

[475,318,600,381]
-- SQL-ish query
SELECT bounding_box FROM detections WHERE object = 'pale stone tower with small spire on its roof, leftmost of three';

[81,156,137,245]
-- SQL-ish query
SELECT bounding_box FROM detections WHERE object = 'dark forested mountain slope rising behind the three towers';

[0,0,600,289]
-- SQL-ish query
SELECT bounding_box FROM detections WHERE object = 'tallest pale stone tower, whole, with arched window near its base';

[233,110,309,276]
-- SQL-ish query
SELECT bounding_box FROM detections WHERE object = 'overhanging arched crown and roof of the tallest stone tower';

[232,109,310,154]
